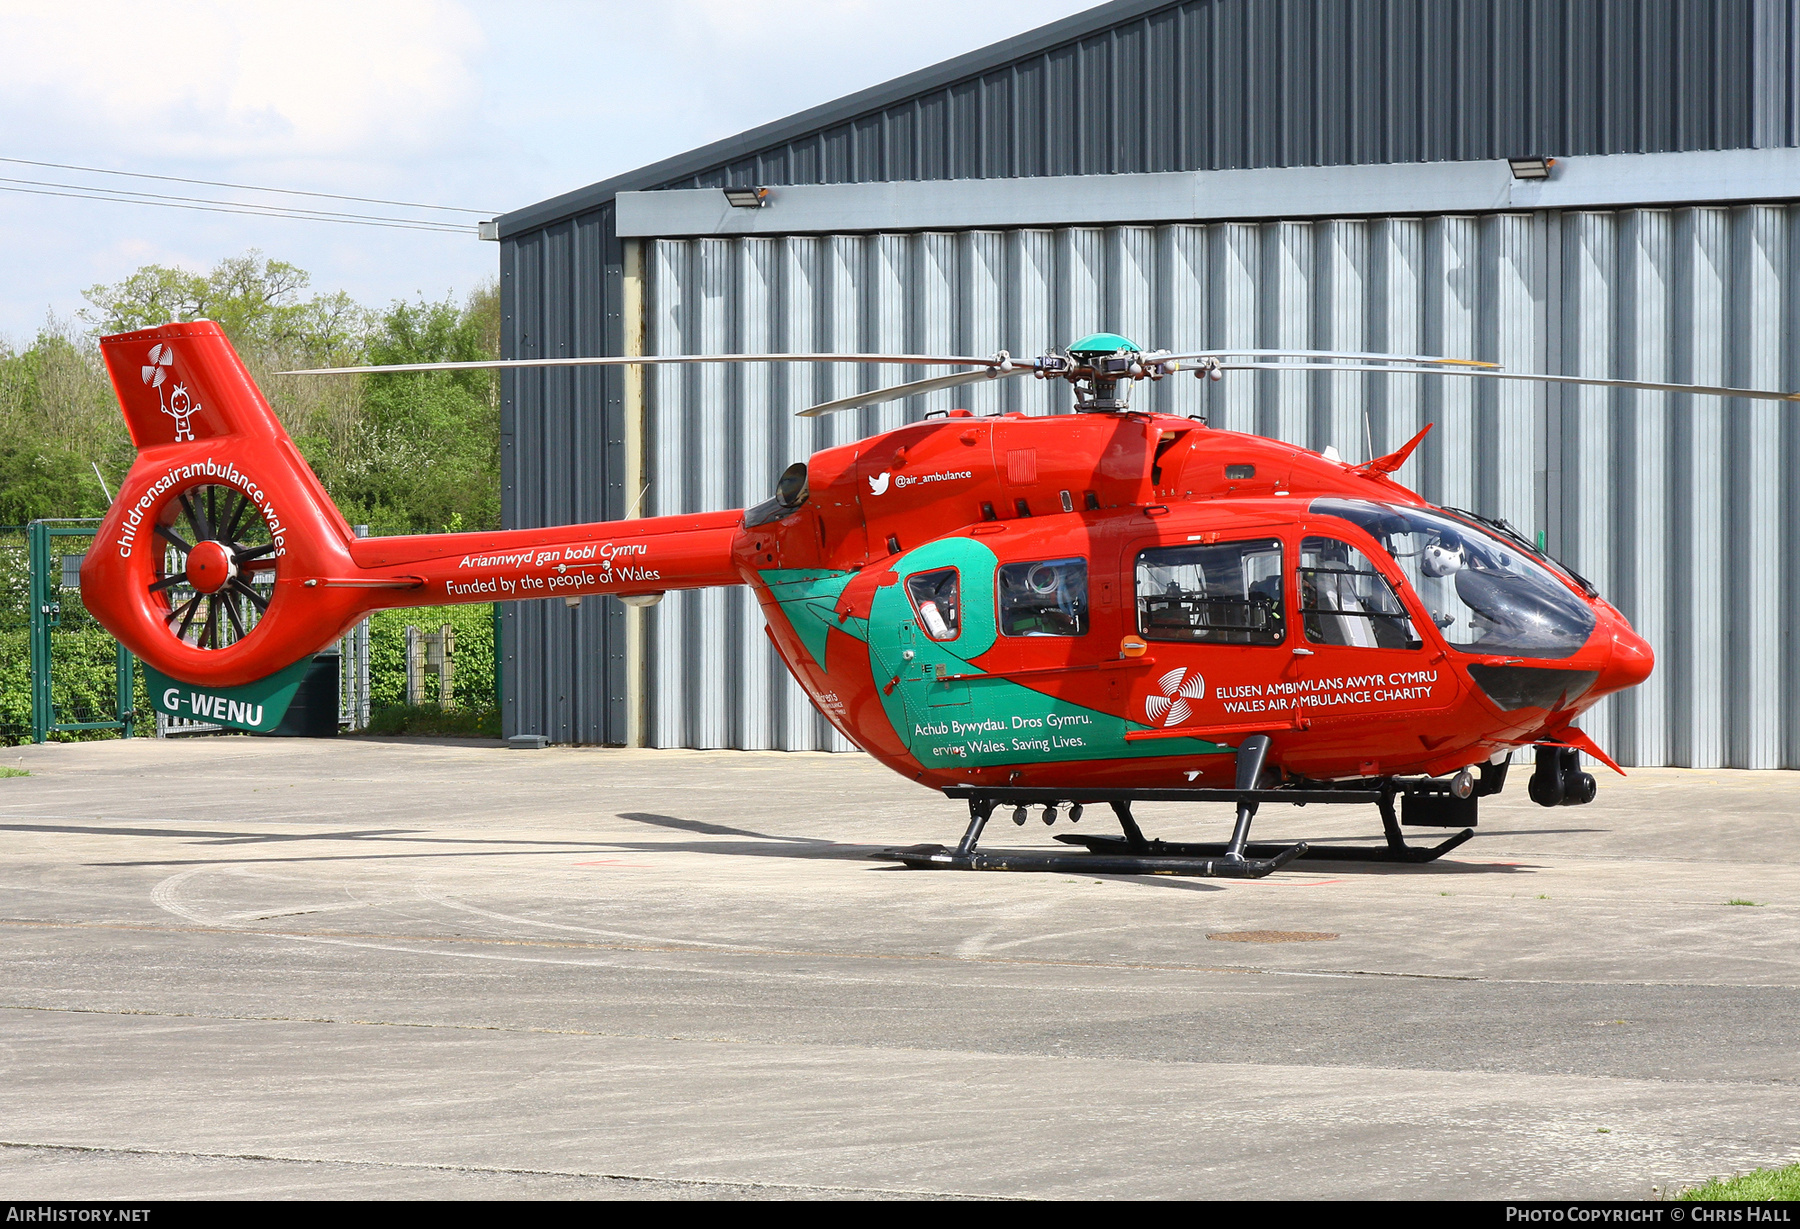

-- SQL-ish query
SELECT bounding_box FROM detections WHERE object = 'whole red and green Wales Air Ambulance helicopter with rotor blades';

[81,320,1800,878]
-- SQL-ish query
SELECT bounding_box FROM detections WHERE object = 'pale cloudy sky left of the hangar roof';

[0,0,1091,345]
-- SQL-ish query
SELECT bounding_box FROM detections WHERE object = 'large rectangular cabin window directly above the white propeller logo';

[1138,538,1287,644]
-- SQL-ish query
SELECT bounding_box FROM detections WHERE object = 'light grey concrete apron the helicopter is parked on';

[0,738,1800,1198]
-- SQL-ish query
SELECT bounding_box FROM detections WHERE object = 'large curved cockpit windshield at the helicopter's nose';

[1312,498,1595,657]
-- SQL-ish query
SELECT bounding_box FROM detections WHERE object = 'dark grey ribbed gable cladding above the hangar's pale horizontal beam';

[658,0,1771,187]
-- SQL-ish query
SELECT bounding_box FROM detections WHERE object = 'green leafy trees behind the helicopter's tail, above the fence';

[0,252,500,533]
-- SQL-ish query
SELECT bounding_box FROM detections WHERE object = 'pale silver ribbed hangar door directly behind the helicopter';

[646,205,1800,767]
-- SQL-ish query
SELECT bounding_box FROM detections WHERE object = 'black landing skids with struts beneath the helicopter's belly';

[875,734,1474,880]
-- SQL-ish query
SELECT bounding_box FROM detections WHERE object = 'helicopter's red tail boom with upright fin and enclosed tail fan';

[81,320,742,687]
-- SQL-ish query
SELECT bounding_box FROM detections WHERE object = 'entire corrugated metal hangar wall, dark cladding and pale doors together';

[502,0,1800,767]
